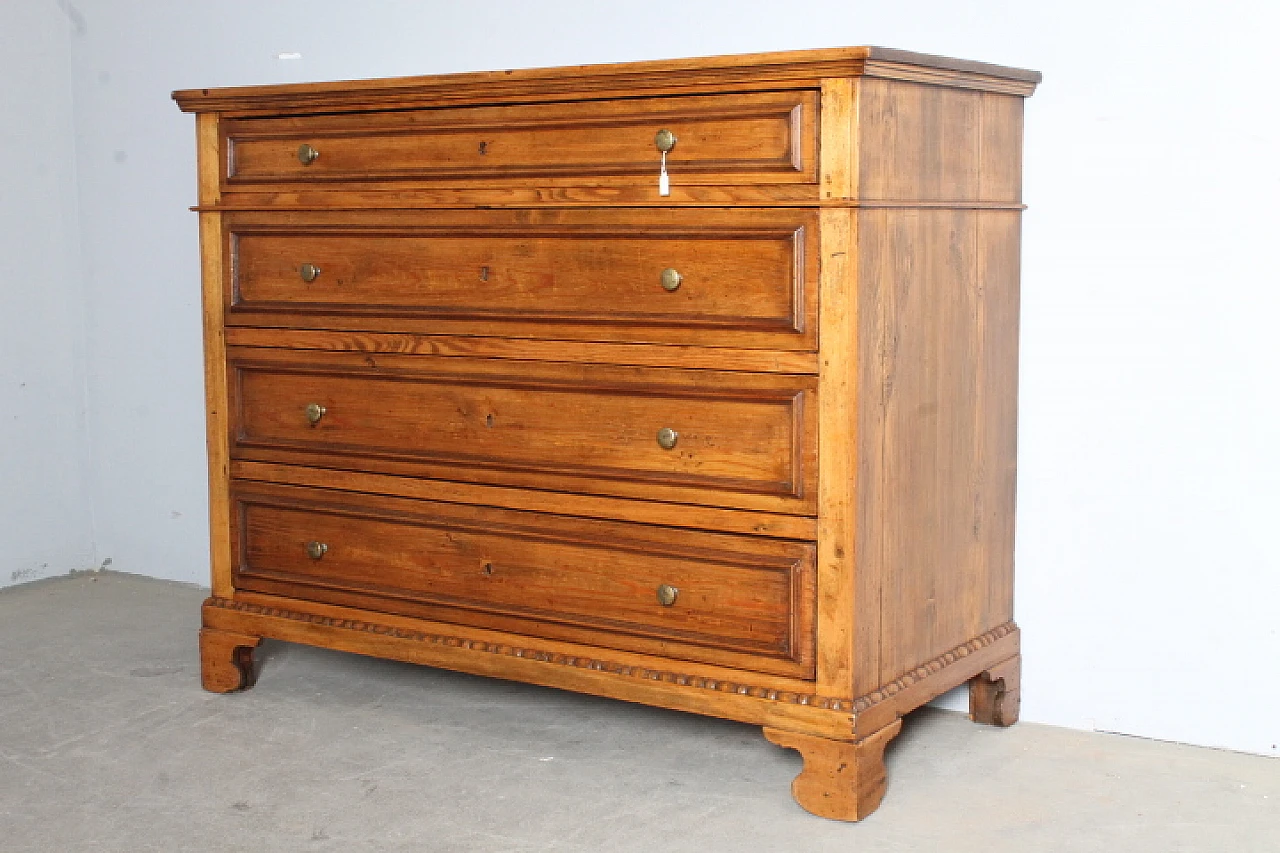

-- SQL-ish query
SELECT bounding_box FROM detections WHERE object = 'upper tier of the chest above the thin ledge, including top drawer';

[174,47,1038,209]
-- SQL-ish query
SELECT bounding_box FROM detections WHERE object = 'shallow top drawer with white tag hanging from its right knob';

[223,91,818,190]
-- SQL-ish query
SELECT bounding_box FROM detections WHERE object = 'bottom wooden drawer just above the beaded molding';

[232,483,815,678]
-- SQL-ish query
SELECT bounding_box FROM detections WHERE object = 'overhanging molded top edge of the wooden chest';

[173,47,1041,115]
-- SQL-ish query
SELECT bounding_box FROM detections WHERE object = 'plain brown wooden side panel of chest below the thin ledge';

[859,211,1018,681]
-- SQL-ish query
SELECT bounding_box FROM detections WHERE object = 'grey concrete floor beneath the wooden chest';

[0,573,1280,853]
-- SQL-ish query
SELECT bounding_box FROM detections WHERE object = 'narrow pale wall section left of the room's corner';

[0,3,93,587]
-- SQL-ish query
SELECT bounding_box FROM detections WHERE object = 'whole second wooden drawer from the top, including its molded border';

[225,209,818,350]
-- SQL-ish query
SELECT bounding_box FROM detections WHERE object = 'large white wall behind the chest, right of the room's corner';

[37,0,1280,754]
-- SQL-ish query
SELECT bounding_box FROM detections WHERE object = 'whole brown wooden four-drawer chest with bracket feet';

[175,47,1039,820]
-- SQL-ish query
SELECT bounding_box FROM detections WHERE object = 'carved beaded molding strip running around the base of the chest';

[205,597,1018,713]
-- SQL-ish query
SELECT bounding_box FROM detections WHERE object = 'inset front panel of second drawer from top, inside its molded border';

[230,222,804,333]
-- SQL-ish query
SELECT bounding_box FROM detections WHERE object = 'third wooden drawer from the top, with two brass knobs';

[229,348,817,515]
